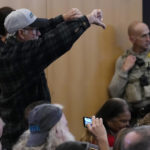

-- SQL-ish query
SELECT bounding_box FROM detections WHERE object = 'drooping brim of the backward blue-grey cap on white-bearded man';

[26,132,48,147]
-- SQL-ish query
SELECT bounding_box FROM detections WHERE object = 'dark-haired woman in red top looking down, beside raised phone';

[81,98,131,148]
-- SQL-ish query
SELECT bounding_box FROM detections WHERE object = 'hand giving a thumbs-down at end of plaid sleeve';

[87,9,106,29]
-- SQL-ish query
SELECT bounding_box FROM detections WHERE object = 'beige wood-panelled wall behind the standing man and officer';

[0,0,142,139]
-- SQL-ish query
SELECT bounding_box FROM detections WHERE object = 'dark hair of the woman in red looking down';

[96,98,129,130]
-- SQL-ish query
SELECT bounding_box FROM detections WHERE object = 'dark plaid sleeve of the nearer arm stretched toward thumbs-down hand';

[19,16,90,73]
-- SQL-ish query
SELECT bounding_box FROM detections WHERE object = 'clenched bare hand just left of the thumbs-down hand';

[63,8,83,21]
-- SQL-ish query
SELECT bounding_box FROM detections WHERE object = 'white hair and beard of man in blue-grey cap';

[13,104,75,150]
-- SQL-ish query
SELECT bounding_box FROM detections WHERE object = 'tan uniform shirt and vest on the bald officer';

[109,48,150,102]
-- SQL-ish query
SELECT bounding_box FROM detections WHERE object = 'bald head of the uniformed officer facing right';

[128,21,150,52]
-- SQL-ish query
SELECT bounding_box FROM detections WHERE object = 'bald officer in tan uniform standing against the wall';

[109,21,150,122]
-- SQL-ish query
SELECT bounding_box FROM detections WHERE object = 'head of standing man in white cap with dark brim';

[4,8,48,41]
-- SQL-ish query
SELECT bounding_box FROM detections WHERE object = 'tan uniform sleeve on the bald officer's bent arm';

[109,56,128,97]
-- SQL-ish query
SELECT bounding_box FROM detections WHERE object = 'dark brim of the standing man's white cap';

[29,18,49,28]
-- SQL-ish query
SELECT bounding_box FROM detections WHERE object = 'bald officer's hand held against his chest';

[122,55,136,72]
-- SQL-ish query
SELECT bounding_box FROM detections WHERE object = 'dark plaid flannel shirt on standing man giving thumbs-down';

[0,16,90,149]
